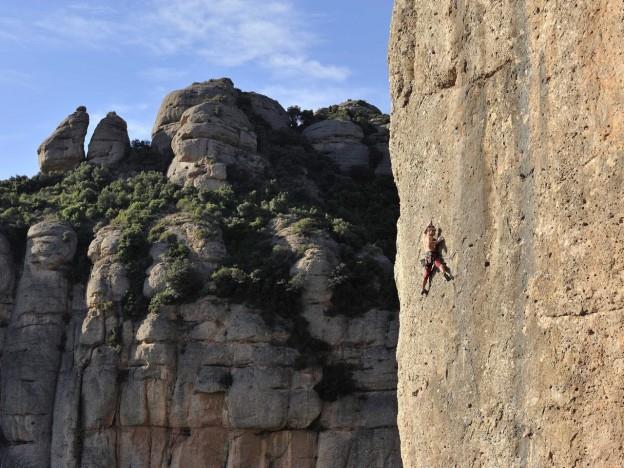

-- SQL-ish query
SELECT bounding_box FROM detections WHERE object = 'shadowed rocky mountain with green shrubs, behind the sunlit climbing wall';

[0,79,401,468]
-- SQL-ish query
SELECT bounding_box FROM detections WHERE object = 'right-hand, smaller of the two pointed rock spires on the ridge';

[87,112,130,166]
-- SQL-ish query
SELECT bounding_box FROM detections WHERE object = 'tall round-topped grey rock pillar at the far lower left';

[0,221,76,466]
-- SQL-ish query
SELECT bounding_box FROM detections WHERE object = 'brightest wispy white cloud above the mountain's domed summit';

[148,0,338,81]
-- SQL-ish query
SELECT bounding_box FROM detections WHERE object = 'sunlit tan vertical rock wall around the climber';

[389,0,624,466]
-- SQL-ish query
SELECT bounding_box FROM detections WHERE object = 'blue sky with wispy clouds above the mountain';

[0,0,392,179]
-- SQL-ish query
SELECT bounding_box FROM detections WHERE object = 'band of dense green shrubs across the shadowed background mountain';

[0,96,398,342]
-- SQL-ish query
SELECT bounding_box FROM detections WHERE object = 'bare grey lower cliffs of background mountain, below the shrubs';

[0,220,401,468]
